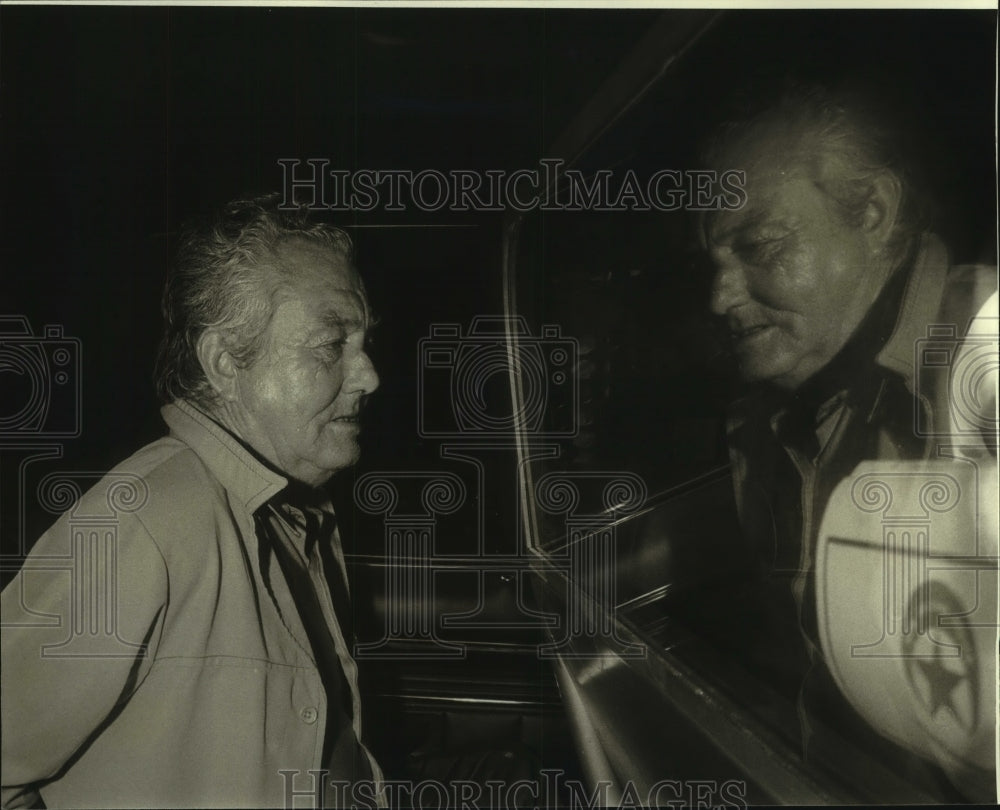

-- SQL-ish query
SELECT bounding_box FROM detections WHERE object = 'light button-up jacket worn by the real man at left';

[2,402,381,807]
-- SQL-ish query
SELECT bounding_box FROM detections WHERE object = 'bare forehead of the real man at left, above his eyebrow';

[276,238,371,328]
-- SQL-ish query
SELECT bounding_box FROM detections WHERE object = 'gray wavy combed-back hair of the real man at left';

[155,189,353,406]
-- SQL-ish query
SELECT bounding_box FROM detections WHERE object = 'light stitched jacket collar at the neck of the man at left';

[160,399,288,513]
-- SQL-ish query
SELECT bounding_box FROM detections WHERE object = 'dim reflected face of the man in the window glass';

[703,128,882,390]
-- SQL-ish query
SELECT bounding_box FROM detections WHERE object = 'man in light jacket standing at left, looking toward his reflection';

[3,196,382,807]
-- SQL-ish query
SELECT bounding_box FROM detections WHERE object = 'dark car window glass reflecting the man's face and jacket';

[510,7,996,800]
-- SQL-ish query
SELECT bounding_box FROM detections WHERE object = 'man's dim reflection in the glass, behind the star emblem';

[699,83,997,799]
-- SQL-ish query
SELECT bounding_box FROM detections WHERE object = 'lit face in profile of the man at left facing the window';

[237,239,378,486]
